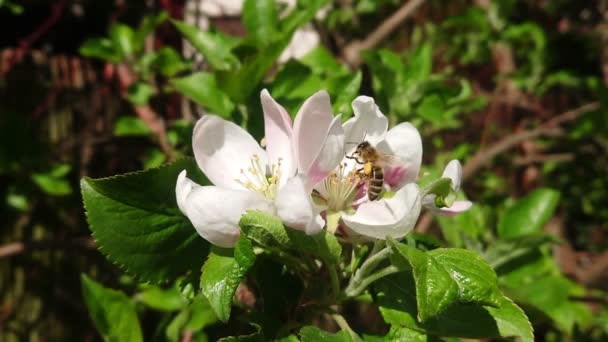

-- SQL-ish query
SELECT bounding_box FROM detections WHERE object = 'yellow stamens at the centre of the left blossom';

[235,154,282,200]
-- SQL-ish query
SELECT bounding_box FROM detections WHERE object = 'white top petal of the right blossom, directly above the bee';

[344,96,388,151]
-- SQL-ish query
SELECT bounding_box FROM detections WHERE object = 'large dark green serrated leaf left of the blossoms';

[80,158,209,282]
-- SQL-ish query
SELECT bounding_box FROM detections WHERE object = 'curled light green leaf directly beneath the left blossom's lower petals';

[239,211,342,264]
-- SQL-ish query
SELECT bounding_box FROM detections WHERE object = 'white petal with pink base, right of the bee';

[378,122,422,189]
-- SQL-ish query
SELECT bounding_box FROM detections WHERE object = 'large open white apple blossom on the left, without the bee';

[176,90,343,247]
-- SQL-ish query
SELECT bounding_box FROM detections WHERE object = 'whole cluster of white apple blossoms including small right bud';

[176,90,471,247]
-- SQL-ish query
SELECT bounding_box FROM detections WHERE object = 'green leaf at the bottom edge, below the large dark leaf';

[81,274,143,342]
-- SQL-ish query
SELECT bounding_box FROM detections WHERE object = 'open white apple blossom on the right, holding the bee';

[314,96,422,239]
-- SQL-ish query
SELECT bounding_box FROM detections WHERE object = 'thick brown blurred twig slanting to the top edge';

[343,0,424,68]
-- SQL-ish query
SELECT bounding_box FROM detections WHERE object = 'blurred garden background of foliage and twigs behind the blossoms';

[0,0,608,341]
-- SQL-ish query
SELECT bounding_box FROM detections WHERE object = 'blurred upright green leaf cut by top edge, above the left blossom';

[243,0,278,46]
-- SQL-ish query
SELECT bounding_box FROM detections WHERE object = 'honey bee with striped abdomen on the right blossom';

[346,141,399,201]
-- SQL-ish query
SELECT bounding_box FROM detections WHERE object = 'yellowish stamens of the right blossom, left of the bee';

[321,164,362,211]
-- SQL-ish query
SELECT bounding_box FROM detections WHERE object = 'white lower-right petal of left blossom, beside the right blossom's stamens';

[275,175,325,235]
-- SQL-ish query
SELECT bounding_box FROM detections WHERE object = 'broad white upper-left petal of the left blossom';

[192,114,267,189]
